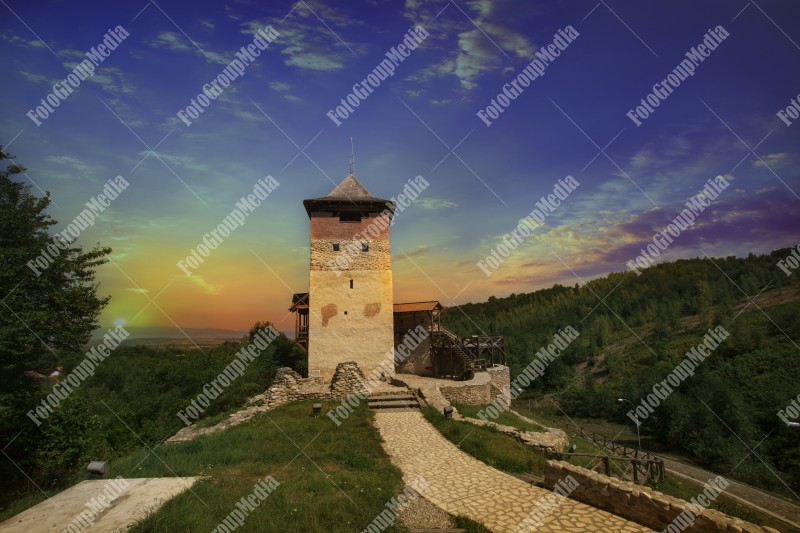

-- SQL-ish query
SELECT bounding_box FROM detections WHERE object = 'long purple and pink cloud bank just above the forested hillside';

[491,187,800,288]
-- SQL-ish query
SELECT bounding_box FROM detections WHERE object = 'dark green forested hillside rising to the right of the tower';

[442,249,800,492]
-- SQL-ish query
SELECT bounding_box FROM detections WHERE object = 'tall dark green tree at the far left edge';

[0,150,111,497]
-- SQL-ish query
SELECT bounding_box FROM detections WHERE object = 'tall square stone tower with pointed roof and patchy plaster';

[303,174,394,382]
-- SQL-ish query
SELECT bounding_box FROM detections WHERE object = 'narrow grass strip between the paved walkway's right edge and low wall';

[423,406,545,475]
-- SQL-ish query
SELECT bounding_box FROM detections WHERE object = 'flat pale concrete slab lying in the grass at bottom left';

[0,477,200,533]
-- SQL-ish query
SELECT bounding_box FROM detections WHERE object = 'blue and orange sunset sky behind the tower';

[0,0,800,330]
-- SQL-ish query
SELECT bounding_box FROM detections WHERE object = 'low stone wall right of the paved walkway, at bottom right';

[544,461,777,533]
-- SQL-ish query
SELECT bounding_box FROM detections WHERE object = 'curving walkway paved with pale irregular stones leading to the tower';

[375,412,652,533]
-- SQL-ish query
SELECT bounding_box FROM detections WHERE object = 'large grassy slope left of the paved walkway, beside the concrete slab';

[108,402,403,533]
